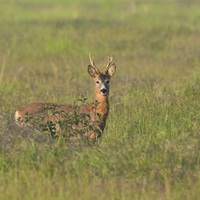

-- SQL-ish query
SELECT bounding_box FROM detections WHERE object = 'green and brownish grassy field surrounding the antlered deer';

[0,0,200,200]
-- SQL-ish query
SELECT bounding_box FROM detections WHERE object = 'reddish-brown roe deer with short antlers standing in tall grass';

[14,55,116,142]
